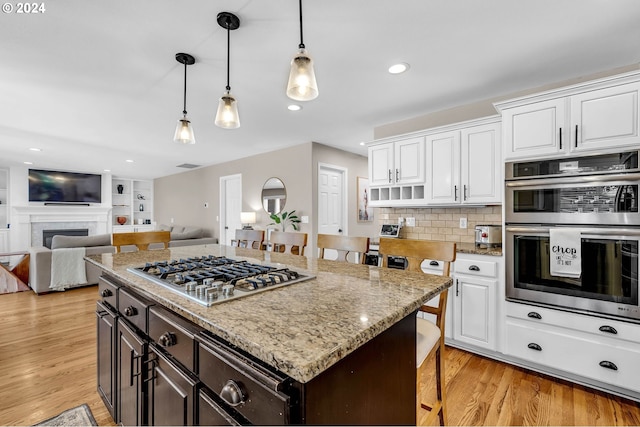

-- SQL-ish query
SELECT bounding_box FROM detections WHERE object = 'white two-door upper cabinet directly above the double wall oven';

[496,72,640,160]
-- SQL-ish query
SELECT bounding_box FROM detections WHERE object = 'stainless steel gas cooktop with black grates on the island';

[127,255,313,306]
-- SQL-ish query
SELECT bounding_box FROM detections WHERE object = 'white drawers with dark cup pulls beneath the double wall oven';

[505,303,640,392]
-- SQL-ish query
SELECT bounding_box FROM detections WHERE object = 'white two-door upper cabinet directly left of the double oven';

[426,120,502,205]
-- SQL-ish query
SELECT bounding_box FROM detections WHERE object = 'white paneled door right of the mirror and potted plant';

[318,164,347,259]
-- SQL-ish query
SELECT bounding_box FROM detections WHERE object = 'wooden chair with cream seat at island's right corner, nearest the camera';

[379,238,456,425]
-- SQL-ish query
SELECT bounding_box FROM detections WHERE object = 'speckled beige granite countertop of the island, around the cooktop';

[85,245,452,383]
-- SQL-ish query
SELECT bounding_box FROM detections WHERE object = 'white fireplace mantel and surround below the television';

[11,205,111,250]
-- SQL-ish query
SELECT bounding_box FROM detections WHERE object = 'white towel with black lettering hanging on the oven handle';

[549,228,582,279]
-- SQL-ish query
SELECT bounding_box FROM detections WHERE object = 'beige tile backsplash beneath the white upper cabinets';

[374,206,502,243]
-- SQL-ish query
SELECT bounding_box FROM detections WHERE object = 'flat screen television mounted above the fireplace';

[29,169,102,204]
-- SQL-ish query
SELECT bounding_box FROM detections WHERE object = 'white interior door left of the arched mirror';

[220,174,242,245]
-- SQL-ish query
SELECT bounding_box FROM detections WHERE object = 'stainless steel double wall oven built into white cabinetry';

[505,150,640,321]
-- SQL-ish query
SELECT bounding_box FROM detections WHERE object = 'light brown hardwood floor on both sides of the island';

[0,286,640,426]
